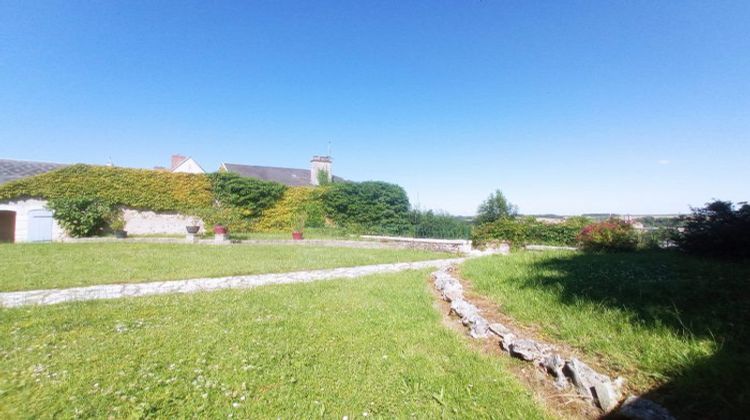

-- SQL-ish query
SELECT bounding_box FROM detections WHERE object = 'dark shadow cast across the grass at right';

[525,251,750,418]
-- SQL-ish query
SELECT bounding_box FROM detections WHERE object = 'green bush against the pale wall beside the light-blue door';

[48,197,113,237]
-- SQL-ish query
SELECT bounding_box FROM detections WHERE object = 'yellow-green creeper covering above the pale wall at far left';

[0,165,213,211]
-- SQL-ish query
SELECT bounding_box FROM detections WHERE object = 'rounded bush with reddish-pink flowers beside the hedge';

[578,219,638,251]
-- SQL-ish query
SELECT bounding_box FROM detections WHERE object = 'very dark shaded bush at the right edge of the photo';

[677,200,750,258]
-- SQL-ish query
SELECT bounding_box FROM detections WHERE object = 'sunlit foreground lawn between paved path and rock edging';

[0,271,547,419]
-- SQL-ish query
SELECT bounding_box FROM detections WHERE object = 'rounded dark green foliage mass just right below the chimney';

[323,181,410,235]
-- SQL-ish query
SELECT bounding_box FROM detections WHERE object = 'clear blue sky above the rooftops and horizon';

[0,0,750,214]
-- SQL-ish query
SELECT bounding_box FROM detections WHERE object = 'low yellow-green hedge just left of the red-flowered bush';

[472,217,590,246]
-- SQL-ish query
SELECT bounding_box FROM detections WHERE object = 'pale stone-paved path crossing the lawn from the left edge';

[0,258,464,308]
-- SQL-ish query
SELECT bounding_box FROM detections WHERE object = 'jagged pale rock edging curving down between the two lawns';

[432,266,674,420]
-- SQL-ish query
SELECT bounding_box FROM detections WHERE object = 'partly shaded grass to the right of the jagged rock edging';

[461,251,750,418]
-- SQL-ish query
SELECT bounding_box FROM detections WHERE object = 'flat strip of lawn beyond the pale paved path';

[0,243,450,291]
